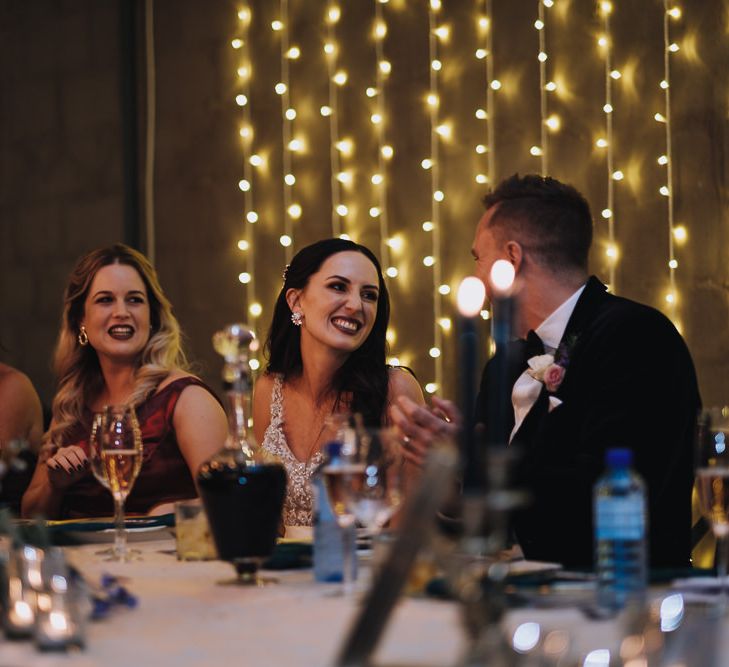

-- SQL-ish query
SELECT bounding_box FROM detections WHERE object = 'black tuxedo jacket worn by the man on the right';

[476,277,700,567]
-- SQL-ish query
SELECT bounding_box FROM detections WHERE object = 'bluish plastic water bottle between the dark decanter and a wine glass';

[311,442,356,583]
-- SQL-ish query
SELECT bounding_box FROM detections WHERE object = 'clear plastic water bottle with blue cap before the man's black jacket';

[593,449,648,610]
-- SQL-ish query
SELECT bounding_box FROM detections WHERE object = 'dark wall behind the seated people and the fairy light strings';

[0,0,729,414]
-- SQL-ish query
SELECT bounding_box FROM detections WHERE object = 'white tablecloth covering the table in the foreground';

[0,539,465,667]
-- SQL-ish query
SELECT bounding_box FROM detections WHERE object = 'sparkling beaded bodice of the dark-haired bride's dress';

[261,375,323,526]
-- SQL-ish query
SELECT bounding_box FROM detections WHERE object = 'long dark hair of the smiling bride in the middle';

[265,238,390,426]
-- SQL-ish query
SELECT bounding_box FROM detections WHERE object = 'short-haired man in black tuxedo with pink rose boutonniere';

[392,175,700,568]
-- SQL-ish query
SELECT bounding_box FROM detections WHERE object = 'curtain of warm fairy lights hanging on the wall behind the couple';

[230,0,687,394]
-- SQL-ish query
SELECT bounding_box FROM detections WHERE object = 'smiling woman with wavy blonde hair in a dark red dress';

[22,244,227,518]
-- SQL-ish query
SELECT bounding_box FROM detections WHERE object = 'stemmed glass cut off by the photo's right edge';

[696,406,729,611]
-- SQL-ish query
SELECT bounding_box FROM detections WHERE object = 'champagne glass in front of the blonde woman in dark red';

[89,405,142,560]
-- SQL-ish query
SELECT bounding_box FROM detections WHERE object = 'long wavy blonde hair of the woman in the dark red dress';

[43,243,187,444]
